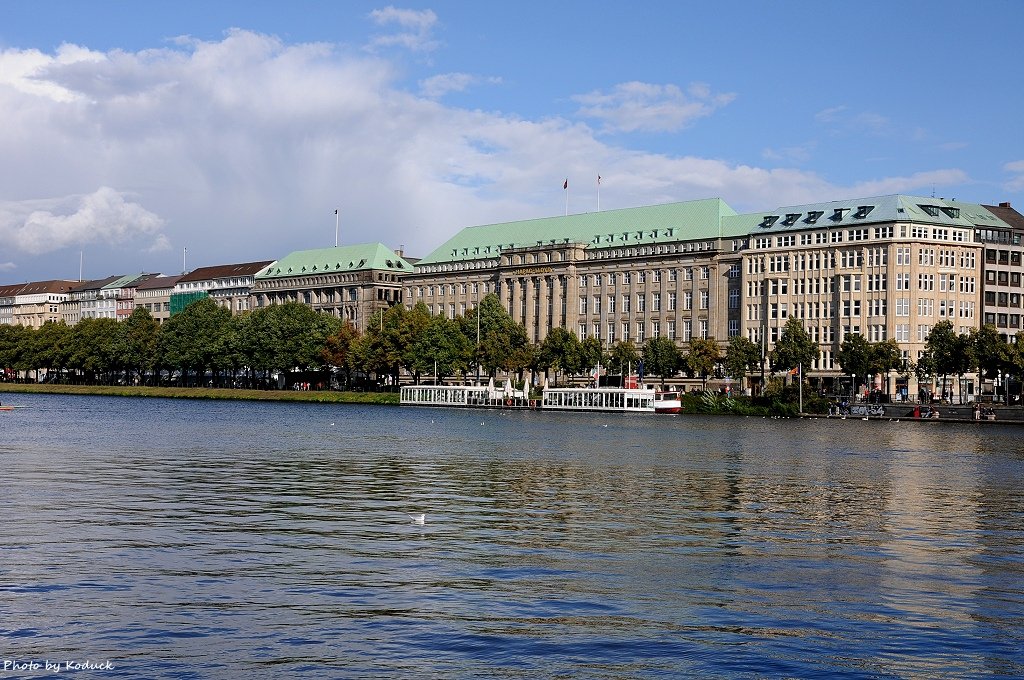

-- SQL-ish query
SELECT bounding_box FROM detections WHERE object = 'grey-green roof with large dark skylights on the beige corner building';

[743,194,1006,235]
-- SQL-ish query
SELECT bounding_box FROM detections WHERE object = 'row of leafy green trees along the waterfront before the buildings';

[0,295,1024,399]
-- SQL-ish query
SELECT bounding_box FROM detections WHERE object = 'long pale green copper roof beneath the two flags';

[417,199,750,265]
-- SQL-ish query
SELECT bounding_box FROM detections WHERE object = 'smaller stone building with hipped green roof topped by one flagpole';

[252,243,413,332]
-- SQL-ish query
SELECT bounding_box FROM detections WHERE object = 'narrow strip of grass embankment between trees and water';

[0,383,398,406]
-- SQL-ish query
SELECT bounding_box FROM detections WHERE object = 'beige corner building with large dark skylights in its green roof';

[743,195,987,395]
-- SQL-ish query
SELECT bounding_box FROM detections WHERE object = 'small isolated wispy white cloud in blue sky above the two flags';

[572,81,735,132]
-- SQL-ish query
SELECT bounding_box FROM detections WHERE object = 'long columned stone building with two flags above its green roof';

[403,199,750,345]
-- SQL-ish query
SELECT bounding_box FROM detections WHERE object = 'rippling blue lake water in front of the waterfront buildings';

[0,394,1024,678]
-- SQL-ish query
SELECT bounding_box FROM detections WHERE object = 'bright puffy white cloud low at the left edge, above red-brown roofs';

[0,186,164,255]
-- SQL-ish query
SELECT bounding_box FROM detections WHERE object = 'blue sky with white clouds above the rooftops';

[0,0,1024,285]
